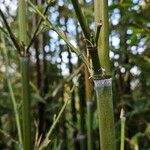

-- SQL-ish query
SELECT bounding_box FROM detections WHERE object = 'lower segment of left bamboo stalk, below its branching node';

[20,57,31,150]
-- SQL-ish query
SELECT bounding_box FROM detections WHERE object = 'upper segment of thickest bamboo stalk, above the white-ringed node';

[94,0,110,74]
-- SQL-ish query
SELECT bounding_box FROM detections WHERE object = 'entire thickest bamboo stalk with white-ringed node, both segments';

[94,0,116,150]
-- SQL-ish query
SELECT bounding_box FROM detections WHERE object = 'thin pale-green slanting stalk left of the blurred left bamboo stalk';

[2,35,22,147]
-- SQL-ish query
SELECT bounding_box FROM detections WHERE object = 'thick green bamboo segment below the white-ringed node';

[94,78,116,150]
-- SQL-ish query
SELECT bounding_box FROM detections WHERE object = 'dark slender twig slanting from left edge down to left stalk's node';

[0,9,21,54]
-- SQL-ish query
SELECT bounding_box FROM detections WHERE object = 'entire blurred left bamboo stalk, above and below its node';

[18,0,32,150]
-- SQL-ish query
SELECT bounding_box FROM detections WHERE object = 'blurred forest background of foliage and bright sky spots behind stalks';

[0,0,150,150]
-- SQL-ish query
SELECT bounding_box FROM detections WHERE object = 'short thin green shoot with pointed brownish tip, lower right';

[120,109,126,150]
